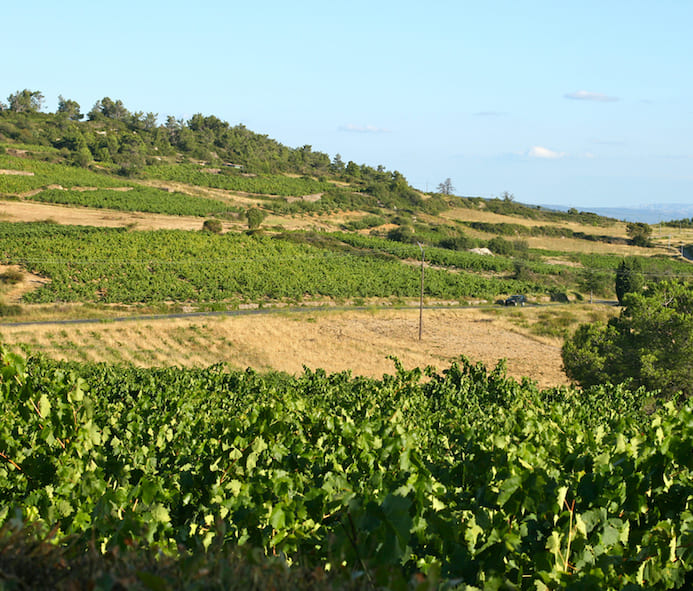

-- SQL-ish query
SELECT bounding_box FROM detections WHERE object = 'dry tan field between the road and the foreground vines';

[0,308,584,387]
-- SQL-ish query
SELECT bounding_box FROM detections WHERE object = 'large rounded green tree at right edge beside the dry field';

[563,281,693,397]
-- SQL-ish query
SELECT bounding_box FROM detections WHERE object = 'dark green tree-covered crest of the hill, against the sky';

[0,90,413,199]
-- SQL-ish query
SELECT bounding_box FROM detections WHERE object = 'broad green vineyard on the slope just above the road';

[0,223,544,303]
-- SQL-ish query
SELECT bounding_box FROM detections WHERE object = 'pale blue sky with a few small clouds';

[0,0,693,209]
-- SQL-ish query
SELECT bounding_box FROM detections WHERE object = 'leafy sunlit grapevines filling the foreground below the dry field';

[0,353,693,589]
